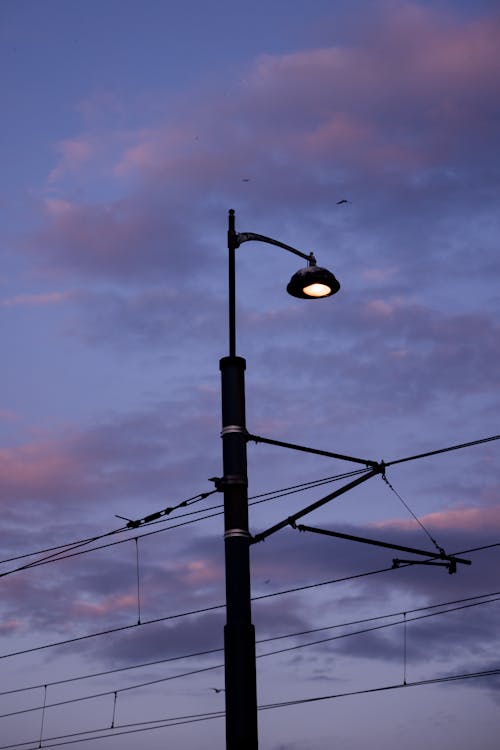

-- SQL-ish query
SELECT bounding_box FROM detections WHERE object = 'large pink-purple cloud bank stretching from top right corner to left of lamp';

[19,2,500,286]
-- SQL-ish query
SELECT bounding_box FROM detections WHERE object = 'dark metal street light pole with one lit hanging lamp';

[219,209,340,750]
